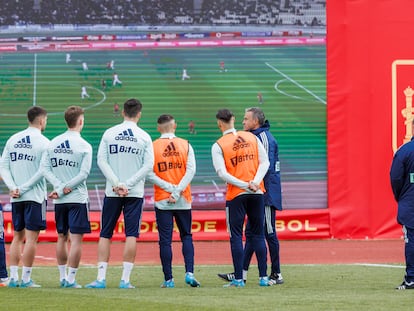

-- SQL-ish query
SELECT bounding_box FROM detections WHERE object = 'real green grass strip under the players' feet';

[0,265,412,311]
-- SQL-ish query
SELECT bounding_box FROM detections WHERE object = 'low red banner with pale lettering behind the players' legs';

[0,209,330,242]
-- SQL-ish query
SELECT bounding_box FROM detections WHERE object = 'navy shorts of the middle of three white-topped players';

[55,203,91,235]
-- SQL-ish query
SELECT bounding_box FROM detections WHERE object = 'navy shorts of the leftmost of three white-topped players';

[12,201,46,231]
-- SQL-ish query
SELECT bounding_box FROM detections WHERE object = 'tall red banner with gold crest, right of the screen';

[327,0,414,238]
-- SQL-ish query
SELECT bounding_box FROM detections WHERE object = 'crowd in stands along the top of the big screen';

[0,0,326,26]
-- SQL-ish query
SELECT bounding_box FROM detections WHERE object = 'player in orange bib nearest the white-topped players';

[147,114,200,288]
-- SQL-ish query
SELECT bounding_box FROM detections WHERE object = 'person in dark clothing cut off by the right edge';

[390,139,414,289]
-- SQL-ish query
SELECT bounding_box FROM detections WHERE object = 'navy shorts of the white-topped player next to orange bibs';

[99,197,144,239]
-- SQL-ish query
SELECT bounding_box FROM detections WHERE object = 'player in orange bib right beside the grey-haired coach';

[211,109,271,287]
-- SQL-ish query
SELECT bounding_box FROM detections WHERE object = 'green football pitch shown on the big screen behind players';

[0,45,326,189]
